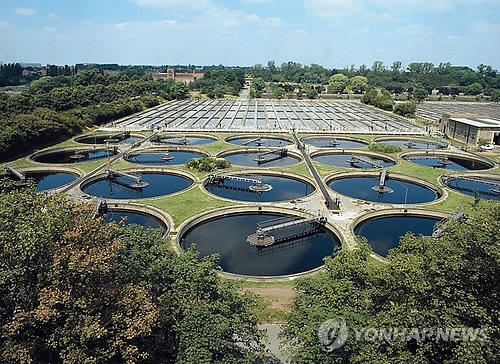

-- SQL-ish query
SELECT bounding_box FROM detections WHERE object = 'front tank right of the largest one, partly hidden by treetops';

[353,210,446,257]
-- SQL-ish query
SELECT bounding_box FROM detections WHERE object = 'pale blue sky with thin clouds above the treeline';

[0,0,500,70]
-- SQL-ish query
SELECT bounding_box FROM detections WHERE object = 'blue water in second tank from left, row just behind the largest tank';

[83,172,193,199]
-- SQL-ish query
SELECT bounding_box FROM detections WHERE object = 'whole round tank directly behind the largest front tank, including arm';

[203,173,315,202]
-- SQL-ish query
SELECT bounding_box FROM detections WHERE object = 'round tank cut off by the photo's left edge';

[3,169,79,192]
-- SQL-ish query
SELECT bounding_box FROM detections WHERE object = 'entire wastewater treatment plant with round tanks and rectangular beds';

[3,100,500,281]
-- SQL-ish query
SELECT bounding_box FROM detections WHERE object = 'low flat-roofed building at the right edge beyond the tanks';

[441,114,500,145]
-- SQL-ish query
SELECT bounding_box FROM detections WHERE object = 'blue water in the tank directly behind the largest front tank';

[205,175,314,202]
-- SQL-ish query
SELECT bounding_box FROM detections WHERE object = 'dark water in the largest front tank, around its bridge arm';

[181,213,339,276]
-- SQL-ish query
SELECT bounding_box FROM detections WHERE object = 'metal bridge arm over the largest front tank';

[247,216,327,247]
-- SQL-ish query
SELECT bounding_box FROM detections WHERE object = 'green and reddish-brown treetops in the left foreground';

[0,183,262,364]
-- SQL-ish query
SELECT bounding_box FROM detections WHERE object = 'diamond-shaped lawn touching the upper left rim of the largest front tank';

[137,186,241,226]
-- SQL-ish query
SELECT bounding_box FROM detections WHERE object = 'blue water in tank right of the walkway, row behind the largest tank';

[328,176,438,204]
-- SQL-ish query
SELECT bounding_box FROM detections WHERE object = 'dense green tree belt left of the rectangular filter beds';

[0,68,189,159]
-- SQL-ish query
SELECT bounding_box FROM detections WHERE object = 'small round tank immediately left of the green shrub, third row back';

[123,149,206,165]
